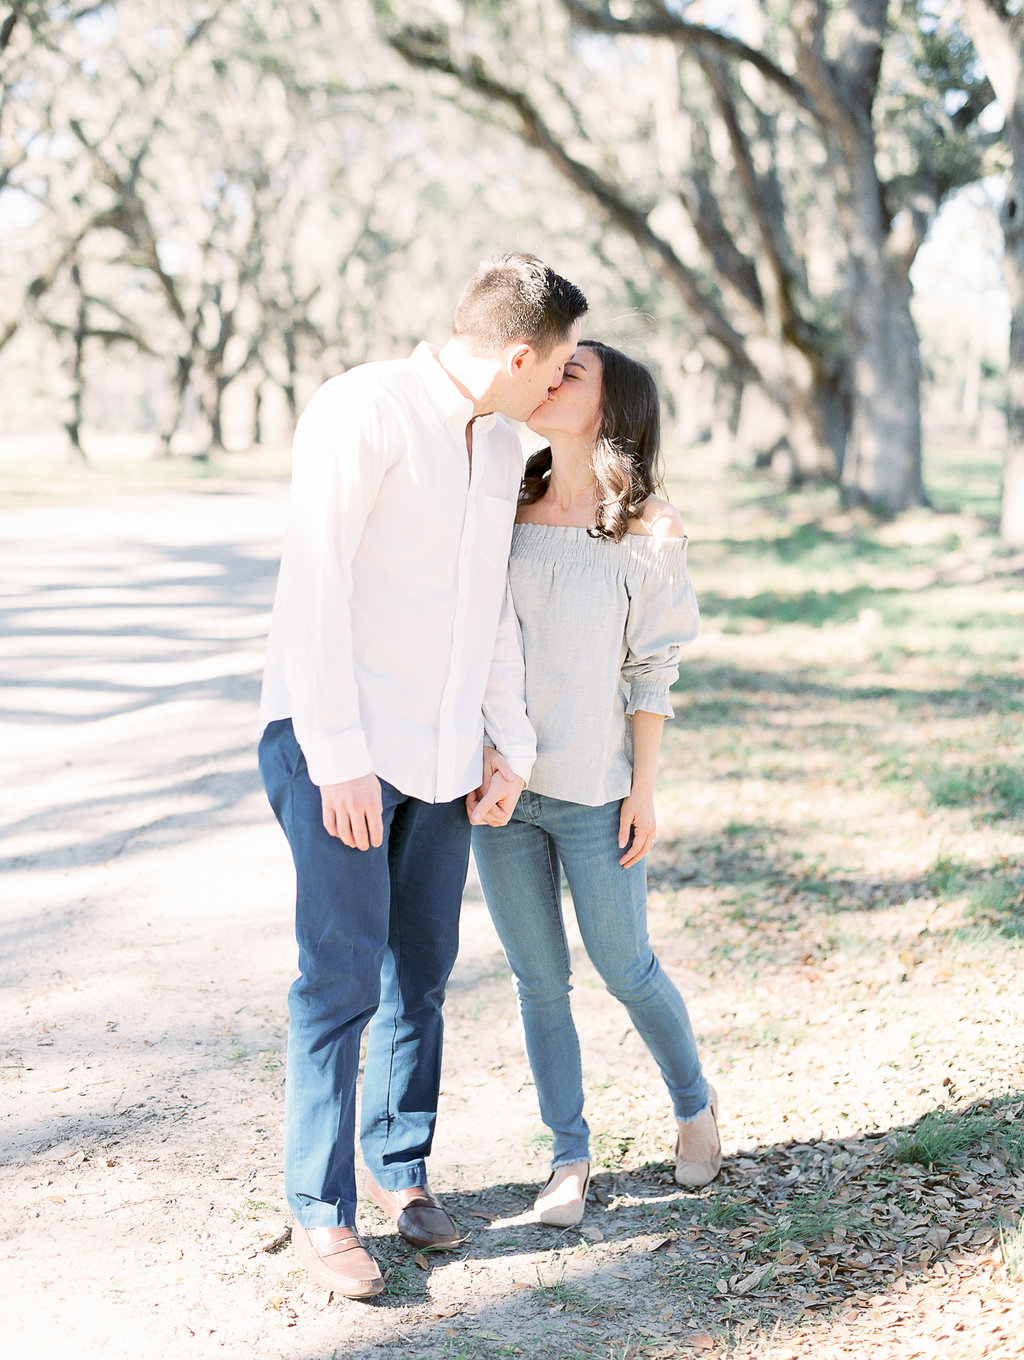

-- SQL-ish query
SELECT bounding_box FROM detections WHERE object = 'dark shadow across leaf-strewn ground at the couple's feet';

[250,1091,1024,1360]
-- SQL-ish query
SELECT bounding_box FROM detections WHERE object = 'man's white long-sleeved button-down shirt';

[260,344,536,802]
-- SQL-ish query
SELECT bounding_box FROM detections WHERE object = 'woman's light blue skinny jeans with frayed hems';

[473,792,710,1167]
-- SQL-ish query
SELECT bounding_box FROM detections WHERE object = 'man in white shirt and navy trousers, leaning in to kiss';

[260,254,586,1299]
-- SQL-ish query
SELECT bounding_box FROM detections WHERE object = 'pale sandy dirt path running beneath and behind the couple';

[0,486,1024,1360]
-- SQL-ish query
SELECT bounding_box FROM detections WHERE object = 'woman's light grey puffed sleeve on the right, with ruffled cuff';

[623,539,700,718]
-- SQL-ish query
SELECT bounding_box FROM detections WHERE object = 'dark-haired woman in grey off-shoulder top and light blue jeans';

[468,340,722,1227]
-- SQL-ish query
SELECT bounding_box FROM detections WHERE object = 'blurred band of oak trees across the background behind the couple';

[0,0,1013,529]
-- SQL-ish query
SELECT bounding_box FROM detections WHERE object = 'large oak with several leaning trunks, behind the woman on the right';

[378,0,990,513]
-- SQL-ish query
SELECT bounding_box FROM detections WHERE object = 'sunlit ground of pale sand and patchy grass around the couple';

[0,462,1024,1360]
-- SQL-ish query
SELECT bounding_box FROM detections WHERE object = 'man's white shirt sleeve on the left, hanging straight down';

[275,374,389,785]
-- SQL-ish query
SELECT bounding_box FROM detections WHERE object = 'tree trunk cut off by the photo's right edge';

[964,0,1024,548]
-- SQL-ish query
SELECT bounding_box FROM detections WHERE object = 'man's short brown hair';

[451,253,587,355]
